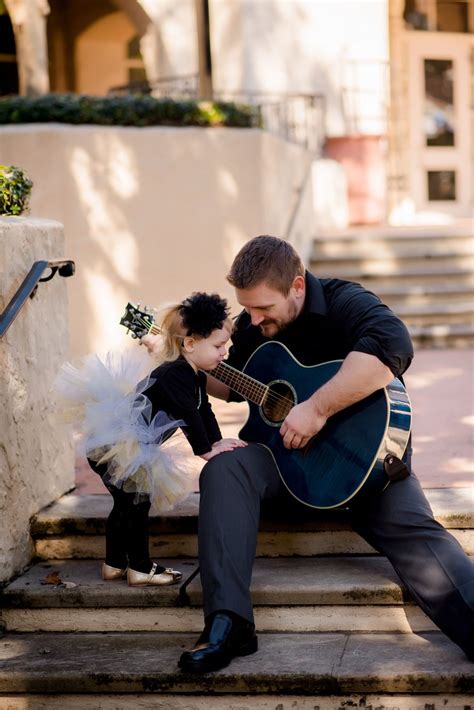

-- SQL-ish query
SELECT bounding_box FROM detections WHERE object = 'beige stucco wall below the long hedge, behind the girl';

[0,124,316,354]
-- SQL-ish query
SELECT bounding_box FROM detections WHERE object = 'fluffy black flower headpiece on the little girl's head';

[179,291,229,338]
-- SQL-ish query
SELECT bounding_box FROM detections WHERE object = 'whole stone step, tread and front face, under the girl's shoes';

[0,557,444,633]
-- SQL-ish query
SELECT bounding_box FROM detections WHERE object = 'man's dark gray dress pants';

[199,444,474,660]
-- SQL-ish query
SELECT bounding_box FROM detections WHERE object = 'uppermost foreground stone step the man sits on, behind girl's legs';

[31,488,474,559]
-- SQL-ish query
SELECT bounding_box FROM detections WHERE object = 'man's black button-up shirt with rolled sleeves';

[228,272,413,386]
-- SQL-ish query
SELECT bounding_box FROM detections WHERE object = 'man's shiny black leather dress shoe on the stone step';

[178,611,258,673]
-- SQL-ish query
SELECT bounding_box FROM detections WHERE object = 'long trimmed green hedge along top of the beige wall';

[0,94,259,128]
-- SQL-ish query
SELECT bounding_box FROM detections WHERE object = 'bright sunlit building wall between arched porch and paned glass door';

[210,0,389,135]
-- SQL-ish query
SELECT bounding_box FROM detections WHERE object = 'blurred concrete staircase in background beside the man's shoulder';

[310,220,474,347]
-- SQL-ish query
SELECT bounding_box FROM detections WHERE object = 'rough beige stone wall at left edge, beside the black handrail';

[0,217,74,582]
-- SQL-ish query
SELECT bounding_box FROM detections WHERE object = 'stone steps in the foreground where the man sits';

[0,488,474,710]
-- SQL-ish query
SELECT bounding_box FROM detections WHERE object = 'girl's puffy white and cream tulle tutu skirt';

[55,348,194,512]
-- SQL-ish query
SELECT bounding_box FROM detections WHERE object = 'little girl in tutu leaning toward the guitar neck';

[58,293,246,586]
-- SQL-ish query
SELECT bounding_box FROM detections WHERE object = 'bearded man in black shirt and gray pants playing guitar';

[179,236,474,672]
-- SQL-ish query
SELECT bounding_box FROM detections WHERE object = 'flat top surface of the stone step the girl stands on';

[0,557,404,609]
